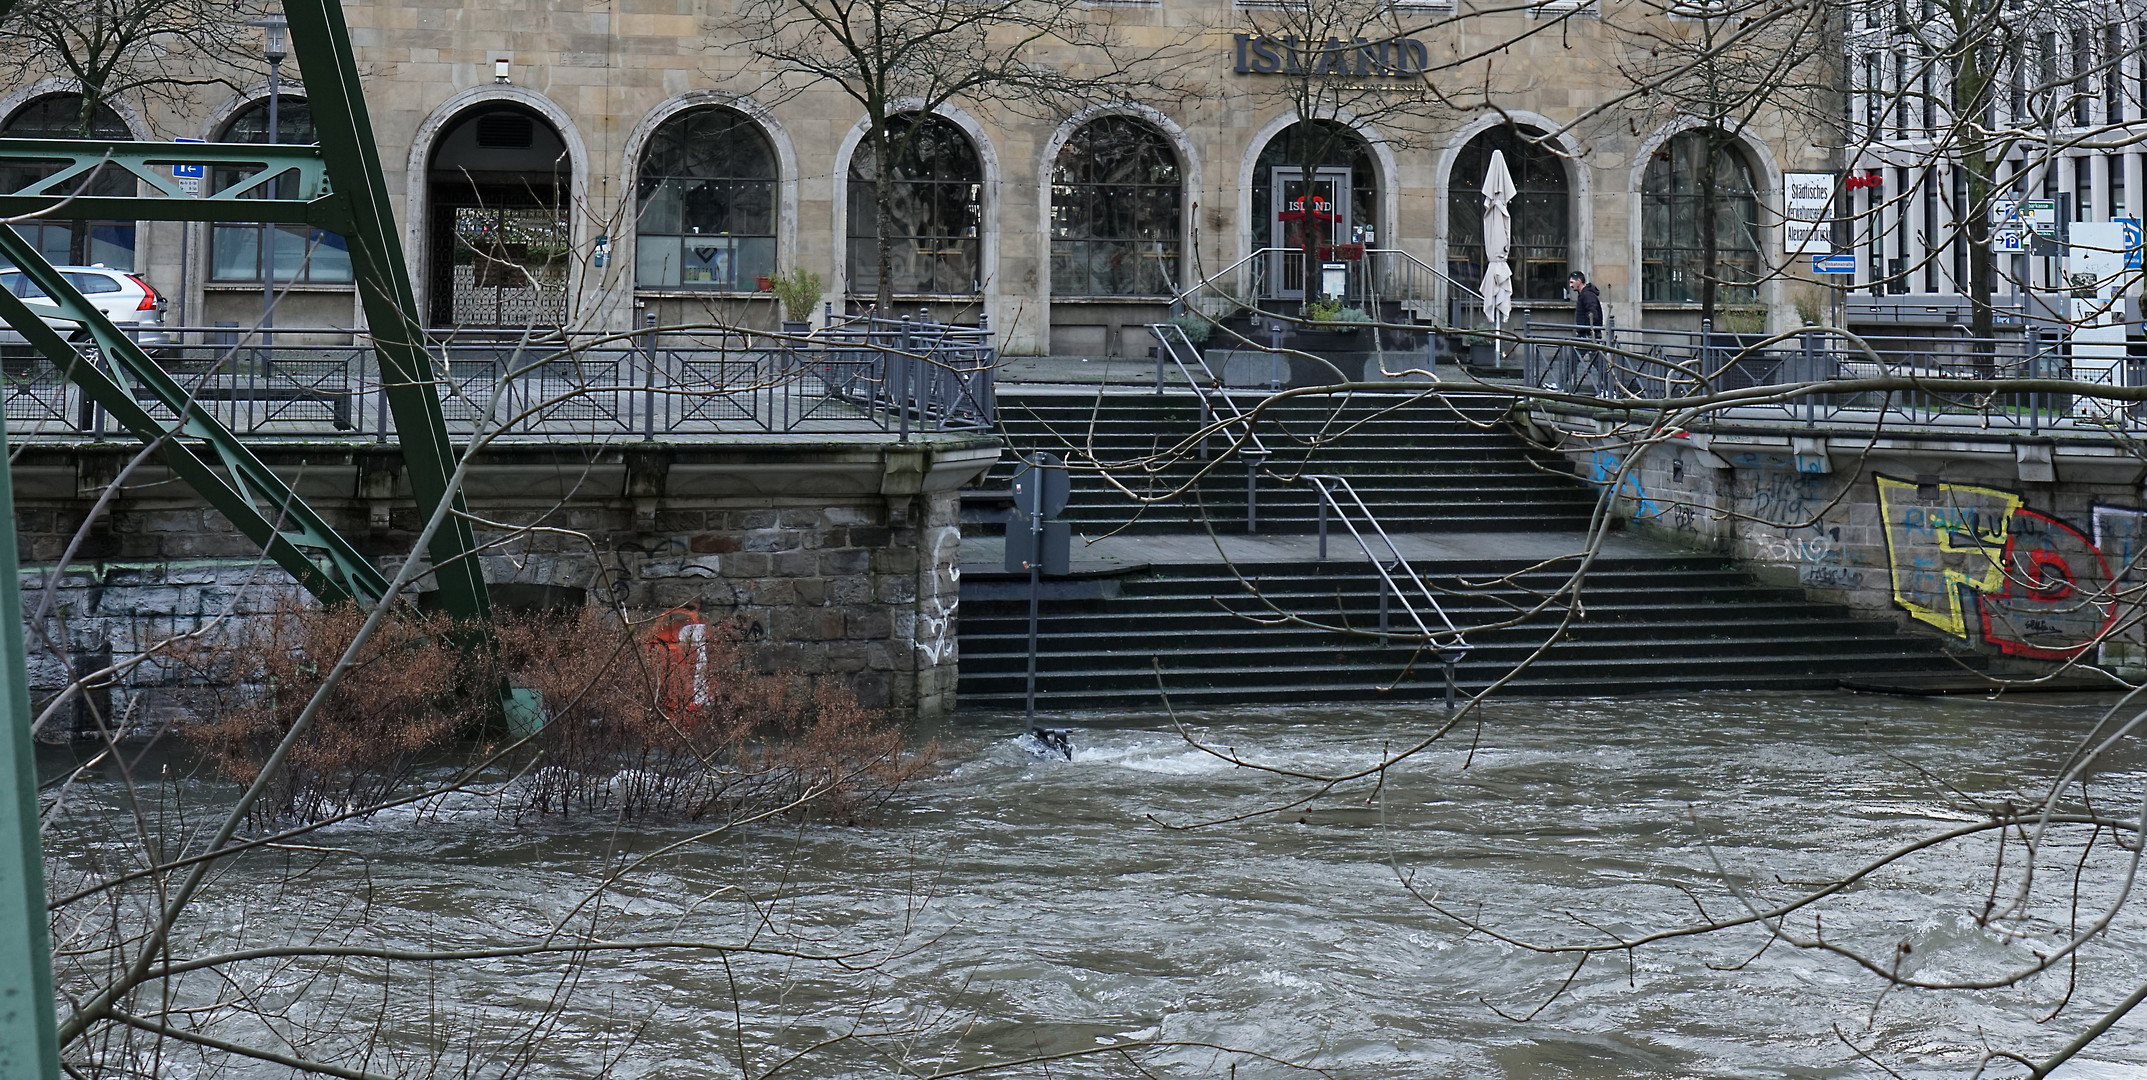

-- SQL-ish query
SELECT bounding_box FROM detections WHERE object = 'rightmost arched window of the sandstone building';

[1640,131,1761,303]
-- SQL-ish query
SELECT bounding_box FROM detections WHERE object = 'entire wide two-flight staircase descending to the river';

[960,393,1960,709]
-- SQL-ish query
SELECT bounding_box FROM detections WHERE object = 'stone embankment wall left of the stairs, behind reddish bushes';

[13,438,998,736]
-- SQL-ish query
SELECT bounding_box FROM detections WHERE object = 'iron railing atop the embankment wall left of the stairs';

[0,316,998,442]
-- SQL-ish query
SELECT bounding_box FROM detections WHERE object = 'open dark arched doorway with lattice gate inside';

[425,101,573,329]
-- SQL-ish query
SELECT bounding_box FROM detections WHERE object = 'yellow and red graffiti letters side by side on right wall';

[1874,475,2117,659]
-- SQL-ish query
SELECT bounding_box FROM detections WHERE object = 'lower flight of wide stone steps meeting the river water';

[960,556,1958,709]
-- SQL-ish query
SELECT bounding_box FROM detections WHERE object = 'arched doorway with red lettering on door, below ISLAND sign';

[1252,120,1385,298]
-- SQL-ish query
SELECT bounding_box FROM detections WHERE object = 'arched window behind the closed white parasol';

[1447,125,1572,301]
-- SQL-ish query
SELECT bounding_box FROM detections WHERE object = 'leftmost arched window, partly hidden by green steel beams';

[0,94,137,271]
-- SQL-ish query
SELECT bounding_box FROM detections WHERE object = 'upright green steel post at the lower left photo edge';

[0,412,60,1080]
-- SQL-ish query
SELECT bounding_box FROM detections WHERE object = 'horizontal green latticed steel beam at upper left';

[0,140,350,232]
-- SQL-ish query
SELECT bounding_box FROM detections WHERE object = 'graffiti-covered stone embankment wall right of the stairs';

[1524,408,2147,676]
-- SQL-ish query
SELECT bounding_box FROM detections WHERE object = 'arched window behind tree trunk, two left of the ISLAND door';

[848,114,983,294]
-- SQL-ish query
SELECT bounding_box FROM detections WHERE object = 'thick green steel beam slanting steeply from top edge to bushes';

[283,0,492,621]
